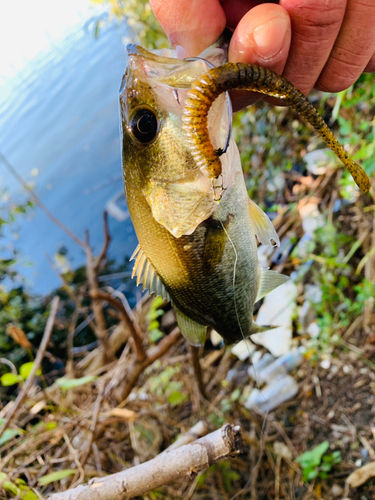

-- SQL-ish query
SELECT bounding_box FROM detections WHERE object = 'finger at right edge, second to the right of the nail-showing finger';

[316,0,375,92]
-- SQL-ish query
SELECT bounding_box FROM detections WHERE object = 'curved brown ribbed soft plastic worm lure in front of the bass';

[182,63,371,193]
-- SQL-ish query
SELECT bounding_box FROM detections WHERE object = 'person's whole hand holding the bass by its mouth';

[150,0,375,109]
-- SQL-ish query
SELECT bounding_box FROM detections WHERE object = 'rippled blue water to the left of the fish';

[0,20,137,293]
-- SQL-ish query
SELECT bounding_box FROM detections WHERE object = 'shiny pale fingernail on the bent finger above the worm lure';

[253,16,289,61]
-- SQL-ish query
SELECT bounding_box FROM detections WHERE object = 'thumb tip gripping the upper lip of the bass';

[150,0,226,57]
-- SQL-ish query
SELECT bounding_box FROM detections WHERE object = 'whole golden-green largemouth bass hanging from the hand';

[120,40,370,345]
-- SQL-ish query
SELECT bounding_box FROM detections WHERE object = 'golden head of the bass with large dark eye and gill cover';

[120,45,238,238]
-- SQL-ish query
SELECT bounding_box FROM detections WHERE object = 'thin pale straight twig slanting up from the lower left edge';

[0,297,60,437]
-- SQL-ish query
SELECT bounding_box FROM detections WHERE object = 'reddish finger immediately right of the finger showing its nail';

[280,0,346,94]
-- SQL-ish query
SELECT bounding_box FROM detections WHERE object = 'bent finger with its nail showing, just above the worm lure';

[229,4,291,110]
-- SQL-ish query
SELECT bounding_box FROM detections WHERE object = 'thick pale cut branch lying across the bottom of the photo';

[50,424,242,500]
